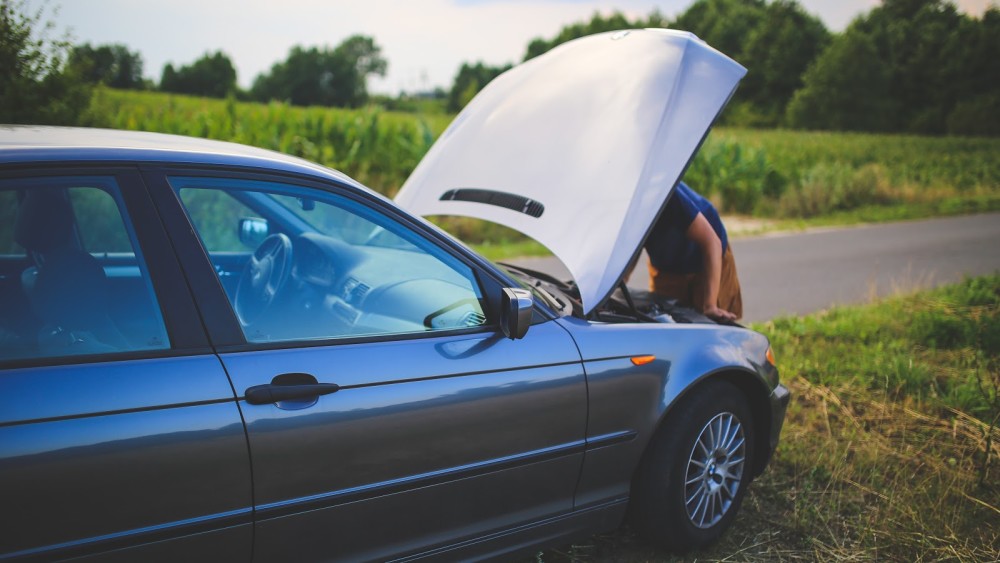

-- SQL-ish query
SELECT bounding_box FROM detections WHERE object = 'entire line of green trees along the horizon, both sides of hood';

[0,0,1000,135]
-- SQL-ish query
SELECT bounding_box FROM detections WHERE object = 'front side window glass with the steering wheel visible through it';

[170,177,487,342]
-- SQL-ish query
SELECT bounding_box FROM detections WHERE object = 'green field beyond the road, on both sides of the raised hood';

[81,88,1000,252]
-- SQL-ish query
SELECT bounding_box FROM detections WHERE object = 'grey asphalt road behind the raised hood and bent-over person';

[513,213,1000,322]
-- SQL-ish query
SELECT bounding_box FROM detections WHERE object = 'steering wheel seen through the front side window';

[235,233,292,325]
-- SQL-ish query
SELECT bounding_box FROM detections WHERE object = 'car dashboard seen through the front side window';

[255,232,487,340]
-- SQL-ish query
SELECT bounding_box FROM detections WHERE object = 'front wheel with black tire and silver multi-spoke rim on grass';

[630,380,754,553]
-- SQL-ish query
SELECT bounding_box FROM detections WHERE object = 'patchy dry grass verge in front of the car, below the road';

[537,275,1000,562]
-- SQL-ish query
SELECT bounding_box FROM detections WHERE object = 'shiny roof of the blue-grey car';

[0,125,361,187]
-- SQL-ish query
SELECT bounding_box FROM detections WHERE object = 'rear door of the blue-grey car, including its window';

[0,167,253,561]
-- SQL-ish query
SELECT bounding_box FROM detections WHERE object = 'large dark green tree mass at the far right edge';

[788,0,1000,134]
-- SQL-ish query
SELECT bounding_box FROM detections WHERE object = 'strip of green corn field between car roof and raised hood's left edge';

[84,88,451,196]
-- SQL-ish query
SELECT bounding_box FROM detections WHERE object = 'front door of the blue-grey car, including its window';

[149,171,586,561]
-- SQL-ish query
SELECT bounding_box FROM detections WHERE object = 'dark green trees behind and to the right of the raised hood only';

[448,0,1000,135]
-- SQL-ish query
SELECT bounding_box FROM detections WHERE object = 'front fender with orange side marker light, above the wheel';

[558,317,777,506]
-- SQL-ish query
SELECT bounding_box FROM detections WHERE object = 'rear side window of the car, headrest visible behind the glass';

[0,176,170,360]
